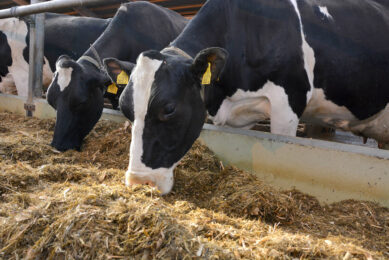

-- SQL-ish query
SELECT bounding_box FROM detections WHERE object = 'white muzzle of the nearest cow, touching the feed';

[126,166,175,195]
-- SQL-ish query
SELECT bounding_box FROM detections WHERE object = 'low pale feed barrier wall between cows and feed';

[0,94,389,207]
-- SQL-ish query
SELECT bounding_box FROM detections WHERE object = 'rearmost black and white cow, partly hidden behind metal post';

[0,13,111,96]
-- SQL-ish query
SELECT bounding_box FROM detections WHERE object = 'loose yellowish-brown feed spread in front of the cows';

[0,113,389,259]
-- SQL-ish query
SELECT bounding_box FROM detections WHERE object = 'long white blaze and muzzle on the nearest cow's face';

[126,54,176,194]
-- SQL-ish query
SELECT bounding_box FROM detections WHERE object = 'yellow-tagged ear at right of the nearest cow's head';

[192,47,228,85]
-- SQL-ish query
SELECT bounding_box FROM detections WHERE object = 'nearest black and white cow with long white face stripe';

[120,0,389,194]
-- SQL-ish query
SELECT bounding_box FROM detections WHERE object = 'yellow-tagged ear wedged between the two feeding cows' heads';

[103,58,135,84]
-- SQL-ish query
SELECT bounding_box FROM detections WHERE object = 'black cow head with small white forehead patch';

[47,56,110,151]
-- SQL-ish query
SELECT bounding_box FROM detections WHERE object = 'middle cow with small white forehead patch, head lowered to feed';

[47,2,187,151]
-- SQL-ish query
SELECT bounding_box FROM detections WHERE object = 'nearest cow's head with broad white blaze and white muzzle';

[119,48,228,194]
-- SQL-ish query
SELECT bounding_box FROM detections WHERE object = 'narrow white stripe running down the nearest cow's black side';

[290,0,316,104]
